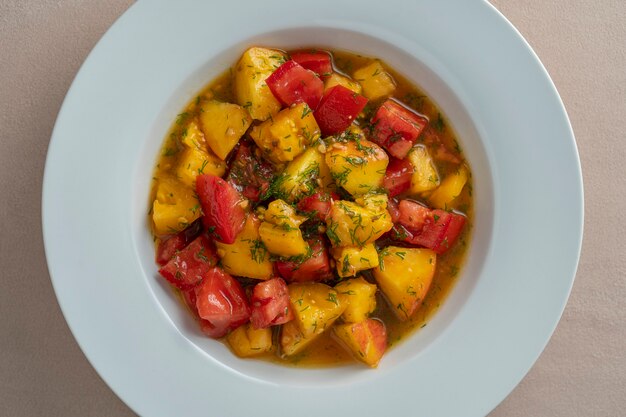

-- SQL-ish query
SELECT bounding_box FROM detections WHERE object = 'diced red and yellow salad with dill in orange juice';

[150,47,473,367]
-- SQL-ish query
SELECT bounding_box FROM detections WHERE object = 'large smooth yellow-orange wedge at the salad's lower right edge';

[374,246,437,321]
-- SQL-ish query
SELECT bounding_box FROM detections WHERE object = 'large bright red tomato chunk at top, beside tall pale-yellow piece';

[265,60,324,109]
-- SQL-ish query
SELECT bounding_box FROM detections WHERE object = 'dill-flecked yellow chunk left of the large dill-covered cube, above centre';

[275,147,335,202]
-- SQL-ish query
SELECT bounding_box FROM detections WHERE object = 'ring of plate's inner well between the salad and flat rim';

[129,27,494,387]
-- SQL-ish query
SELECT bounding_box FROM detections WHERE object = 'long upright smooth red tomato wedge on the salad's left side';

[196,174,248,243]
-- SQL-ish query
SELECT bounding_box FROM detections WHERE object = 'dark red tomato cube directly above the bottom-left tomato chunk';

[159,235,218,290]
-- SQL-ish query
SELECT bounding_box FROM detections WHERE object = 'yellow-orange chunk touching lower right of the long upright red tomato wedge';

[215,214,274,279]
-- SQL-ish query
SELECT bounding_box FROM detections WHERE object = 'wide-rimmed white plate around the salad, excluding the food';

[43,0,583,417]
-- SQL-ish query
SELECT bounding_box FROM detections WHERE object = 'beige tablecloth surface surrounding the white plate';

[0,0,626,417]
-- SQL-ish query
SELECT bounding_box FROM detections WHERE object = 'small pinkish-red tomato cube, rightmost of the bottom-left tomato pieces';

[250,278,294,329]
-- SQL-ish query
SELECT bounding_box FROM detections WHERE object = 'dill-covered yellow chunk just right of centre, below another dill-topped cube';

[326,195,393,247]
